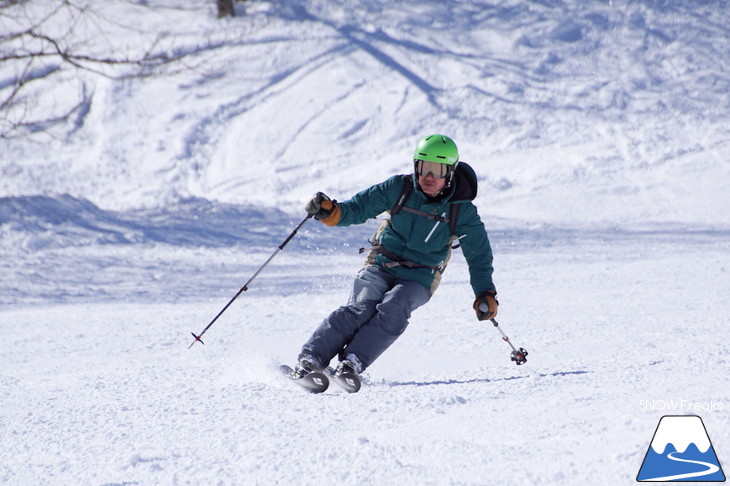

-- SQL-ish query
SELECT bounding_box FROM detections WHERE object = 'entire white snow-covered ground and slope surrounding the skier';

[0,0,730,485]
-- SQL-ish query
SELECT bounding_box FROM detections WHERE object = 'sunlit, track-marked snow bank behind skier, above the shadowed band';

[0,0,730,226]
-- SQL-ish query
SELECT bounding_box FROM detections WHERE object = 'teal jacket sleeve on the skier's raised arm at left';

[337,176,405,226]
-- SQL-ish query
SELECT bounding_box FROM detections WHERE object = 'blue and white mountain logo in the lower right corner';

[636,415,725,483]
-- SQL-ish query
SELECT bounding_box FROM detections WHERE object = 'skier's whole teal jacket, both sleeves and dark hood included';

[337,162,496,295]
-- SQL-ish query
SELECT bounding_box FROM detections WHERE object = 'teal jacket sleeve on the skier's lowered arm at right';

[455,203,497,295]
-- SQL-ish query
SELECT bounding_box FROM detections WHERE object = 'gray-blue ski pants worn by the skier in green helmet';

[302,266,431,370]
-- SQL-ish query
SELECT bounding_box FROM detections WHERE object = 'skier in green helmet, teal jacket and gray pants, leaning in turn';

[294,135,499,382]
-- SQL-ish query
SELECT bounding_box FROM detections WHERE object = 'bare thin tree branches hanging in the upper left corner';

[0,0,222,138]
